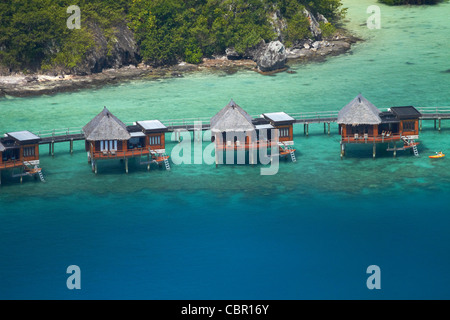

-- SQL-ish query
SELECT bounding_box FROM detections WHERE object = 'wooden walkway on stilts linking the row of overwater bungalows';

[29,107,450,149]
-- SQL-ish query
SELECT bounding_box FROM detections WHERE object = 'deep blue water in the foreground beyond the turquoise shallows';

[0,186,450,299]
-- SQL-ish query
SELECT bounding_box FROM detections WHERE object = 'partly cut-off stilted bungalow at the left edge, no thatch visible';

[0,131,44,183]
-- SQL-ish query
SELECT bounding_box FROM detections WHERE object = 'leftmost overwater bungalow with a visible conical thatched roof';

[83,107,168,173]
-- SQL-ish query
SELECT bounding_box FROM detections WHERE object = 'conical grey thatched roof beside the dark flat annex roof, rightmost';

[337,94,381,126]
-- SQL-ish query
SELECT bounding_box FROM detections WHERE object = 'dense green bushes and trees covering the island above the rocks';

[0,0,344,71]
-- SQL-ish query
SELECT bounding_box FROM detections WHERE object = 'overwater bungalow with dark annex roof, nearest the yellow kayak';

[337,94,421,157]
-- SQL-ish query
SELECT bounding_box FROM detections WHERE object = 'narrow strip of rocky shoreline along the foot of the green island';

[0,33,361,97]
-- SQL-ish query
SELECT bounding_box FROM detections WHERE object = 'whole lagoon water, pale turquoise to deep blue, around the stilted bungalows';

[0,0,450,299]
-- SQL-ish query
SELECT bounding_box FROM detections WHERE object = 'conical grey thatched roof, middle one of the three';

[211,99,255,132]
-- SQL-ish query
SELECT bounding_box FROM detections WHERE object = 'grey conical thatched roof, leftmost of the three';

[83,107,131,141]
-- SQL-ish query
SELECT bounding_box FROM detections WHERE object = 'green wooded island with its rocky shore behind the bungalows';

[0,0,444,96]
